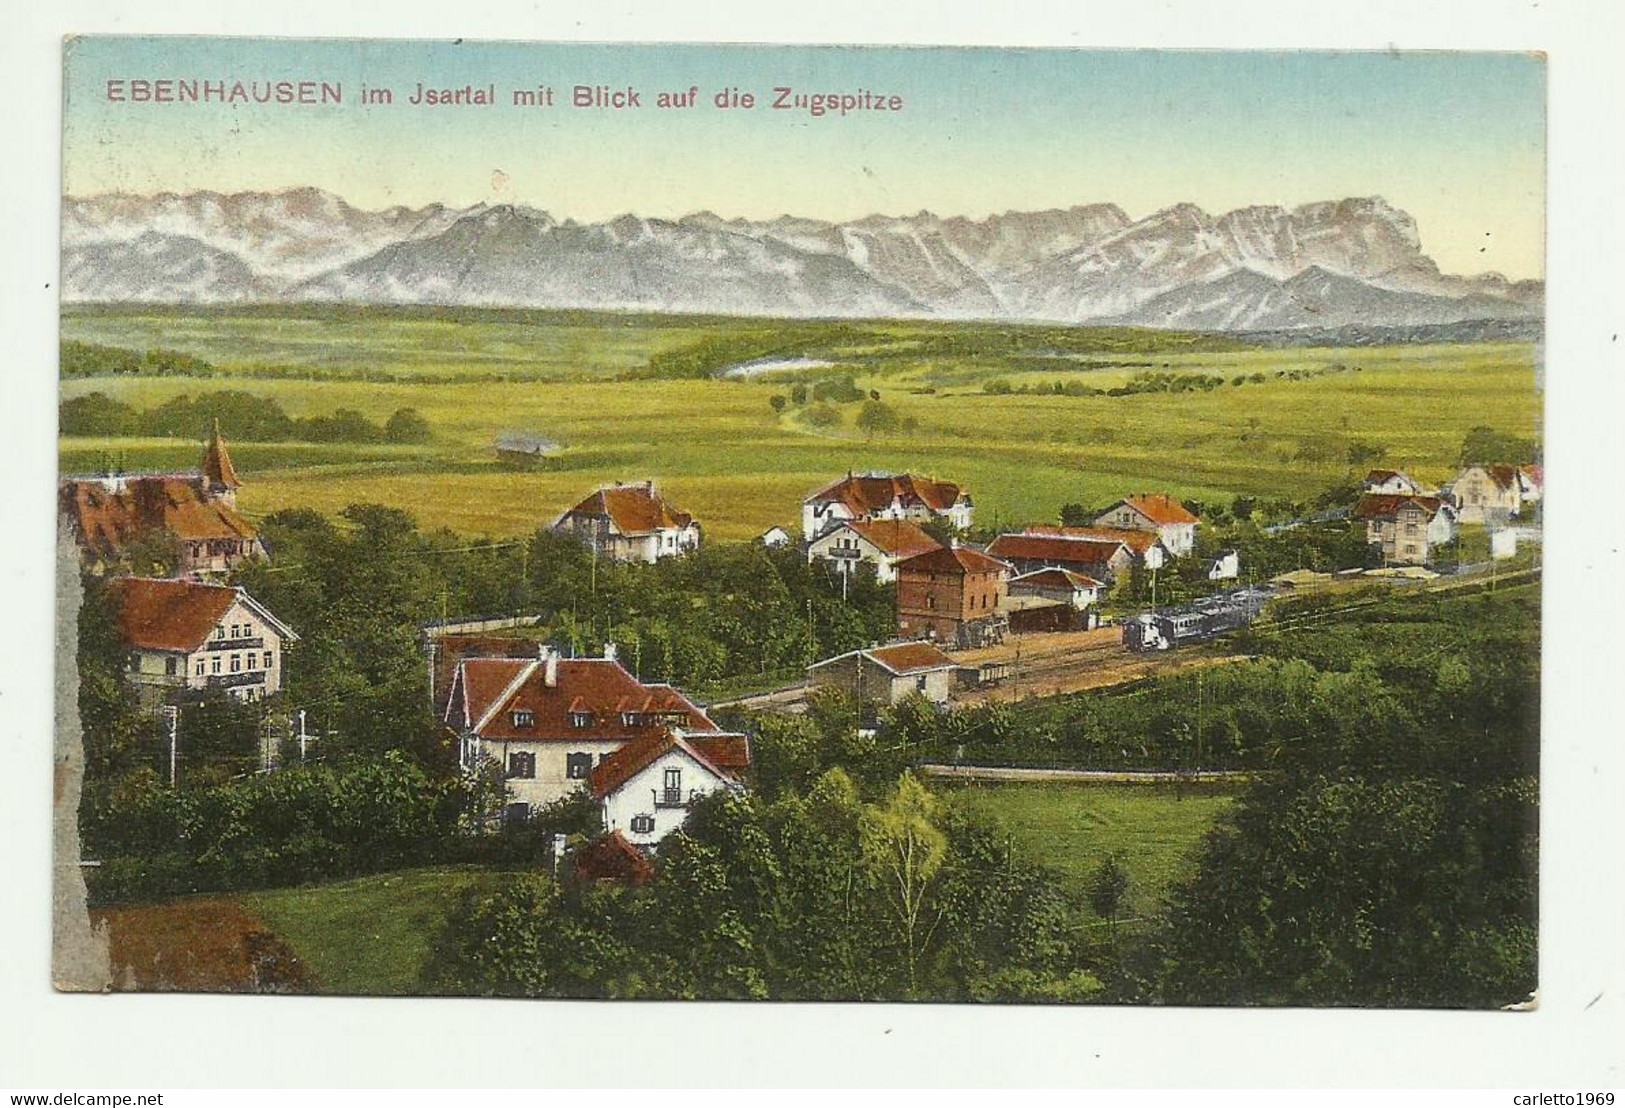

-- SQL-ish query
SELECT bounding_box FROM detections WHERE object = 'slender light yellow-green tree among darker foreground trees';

[863,772,947,996]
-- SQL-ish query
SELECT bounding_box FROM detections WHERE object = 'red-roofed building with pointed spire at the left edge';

[57,424,265,578]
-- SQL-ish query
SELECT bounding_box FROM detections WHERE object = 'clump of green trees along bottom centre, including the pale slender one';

[426,768,1100,1001]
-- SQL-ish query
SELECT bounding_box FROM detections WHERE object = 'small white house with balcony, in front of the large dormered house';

[590,728,751,846]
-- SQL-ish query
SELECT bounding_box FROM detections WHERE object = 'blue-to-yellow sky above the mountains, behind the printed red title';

[63,37,1545,279]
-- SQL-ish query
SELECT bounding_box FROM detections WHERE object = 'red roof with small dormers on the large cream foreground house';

[445,658,717,742]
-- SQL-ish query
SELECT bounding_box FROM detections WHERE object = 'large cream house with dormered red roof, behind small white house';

[442,645,723,819]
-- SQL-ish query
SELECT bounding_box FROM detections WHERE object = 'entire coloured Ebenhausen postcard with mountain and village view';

[54,36,1545,1000]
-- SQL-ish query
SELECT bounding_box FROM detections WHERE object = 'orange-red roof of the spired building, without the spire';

[59,474,257,556]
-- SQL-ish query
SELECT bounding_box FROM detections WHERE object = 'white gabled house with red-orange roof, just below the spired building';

[107,577,299,702]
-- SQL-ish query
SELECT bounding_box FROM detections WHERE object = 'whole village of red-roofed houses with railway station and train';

[60,424,1542,868]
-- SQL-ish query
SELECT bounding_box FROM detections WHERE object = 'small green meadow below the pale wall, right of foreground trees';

[936,781,1237,915]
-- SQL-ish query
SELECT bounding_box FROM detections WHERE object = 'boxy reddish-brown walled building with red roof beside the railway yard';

[897,543,1011,648]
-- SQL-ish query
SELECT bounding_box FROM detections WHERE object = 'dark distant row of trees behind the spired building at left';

[57,390,434,444]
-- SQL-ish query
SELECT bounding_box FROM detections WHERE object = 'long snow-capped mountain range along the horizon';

[62,188,1544,330]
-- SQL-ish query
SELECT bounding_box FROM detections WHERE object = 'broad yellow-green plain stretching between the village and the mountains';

[62,309,1539,539]
